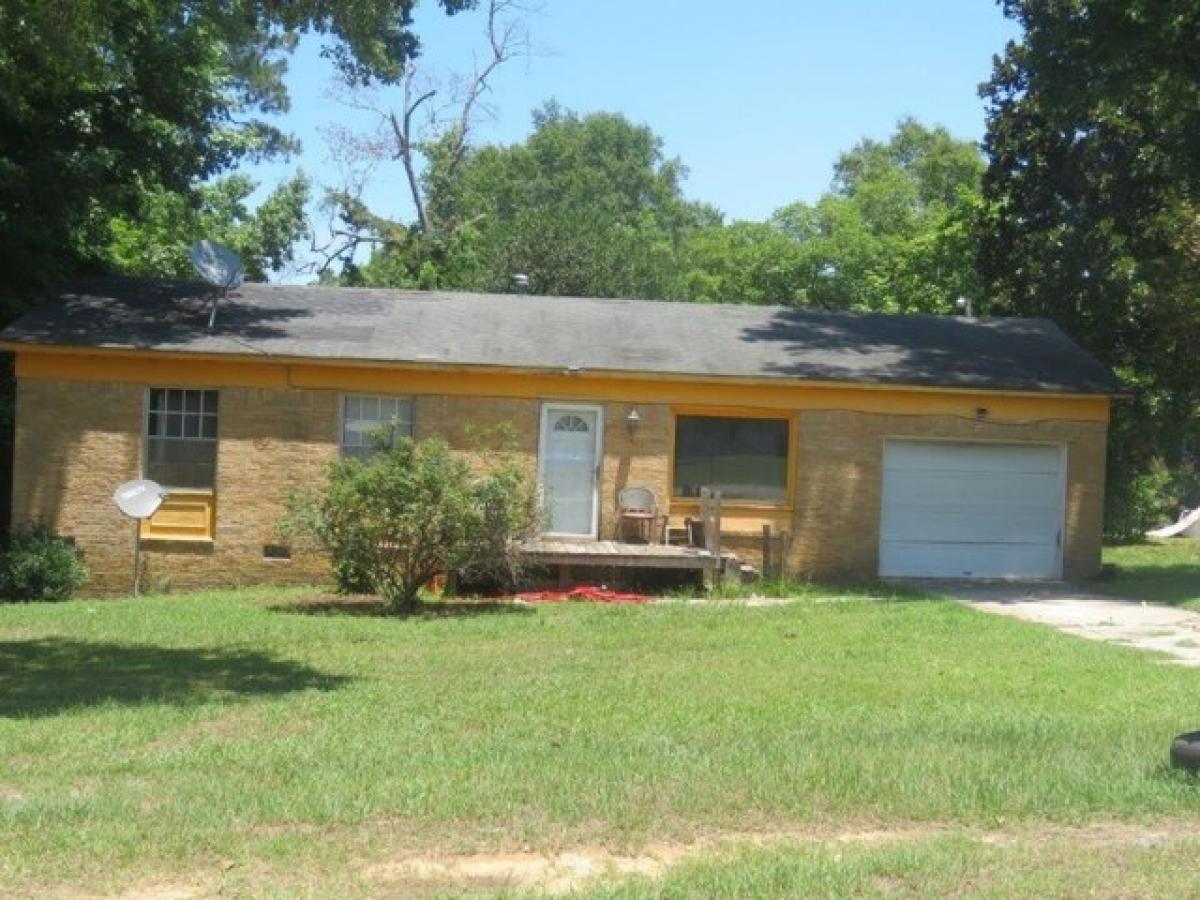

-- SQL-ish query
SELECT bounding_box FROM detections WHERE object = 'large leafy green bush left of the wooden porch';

[288,438,538,612]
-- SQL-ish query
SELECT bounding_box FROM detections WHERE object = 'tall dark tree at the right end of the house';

[979,0,1200,535]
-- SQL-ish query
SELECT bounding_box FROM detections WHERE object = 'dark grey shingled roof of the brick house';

[0,278,1117,394]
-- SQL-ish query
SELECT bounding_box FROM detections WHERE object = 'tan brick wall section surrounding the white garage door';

[788,410,1105,580]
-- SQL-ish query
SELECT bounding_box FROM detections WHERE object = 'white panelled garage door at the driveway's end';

[880,440,1064,578]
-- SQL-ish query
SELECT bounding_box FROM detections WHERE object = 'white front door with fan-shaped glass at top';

[538,403,604,538]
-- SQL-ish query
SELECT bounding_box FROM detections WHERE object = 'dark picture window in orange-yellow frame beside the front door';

[674,415,790,503]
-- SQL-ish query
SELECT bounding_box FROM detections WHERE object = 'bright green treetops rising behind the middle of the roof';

[346,111,983,312]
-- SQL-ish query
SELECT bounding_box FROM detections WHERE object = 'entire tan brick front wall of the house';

[13,378,1105,593]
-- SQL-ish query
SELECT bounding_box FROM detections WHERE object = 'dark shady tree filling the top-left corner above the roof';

[0,0,475,293]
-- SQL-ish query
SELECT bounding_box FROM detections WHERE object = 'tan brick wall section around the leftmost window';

[13,379,337,594]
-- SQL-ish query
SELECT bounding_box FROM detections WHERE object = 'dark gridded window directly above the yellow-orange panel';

[145,388,217,490]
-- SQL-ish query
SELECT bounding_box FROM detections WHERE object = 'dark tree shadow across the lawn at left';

[0,637,347,718]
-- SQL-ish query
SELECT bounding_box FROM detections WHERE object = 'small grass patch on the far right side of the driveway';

[1096,538,1200,612]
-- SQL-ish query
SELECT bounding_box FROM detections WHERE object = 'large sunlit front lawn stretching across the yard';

[0,590,1200,895]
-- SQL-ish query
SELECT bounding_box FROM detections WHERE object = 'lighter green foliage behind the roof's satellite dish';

[107,174,308,281]
